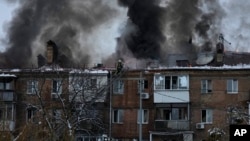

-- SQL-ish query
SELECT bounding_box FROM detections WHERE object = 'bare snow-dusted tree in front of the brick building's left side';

[15,69,108,141]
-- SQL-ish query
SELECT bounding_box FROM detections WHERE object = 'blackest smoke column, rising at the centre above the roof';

[119,0,165,59]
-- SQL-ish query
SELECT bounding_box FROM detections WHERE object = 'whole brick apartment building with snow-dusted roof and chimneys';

[0,37,250,141]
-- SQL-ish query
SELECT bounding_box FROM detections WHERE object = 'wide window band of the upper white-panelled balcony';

[155,75,188,90]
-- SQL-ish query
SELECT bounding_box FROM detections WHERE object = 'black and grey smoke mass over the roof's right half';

[118,0,226,67]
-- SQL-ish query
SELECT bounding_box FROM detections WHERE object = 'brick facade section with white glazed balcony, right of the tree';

[112,67,250,141]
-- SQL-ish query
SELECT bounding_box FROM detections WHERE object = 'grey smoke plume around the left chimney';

[0,0,124,67]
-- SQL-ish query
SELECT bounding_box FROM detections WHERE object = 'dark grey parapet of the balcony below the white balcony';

[155,120,190,131]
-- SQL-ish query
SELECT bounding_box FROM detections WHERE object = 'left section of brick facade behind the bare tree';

[0,66,109,141]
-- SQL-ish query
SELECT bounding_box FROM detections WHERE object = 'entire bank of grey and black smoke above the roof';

[0,0,250,67]
